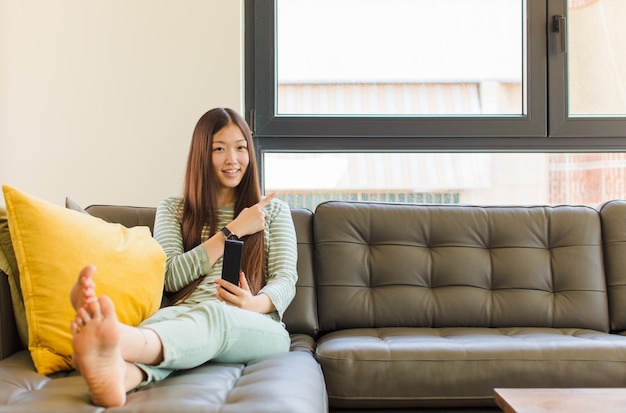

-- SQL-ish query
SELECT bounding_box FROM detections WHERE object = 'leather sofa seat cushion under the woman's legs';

[0,351,328,413]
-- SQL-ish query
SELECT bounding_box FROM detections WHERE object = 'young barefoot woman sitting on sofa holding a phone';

[70,108,297,407]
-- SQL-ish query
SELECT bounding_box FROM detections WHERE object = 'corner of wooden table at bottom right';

[494,388,626,413]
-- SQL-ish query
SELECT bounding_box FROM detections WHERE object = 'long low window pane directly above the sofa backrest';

[264,153,626,210]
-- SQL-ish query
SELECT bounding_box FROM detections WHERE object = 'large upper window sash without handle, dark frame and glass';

[246,0,547,138]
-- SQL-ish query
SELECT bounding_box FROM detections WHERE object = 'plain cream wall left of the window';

[0,0,244,206]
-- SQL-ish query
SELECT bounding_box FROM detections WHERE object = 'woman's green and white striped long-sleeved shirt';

[154,197,298,319]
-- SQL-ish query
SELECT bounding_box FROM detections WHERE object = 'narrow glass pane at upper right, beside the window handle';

[567,0,626,116]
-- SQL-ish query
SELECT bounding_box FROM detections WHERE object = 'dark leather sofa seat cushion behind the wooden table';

[316,327,626,408]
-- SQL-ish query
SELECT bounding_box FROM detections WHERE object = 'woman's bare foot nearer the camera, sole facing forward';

[72,292,126,407]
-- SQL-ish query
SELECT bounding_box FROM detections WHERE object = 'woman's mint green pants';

[137,300,291,385]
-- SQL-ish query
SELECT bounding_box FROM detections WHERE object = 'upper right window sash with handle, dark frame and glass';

[547,0,626,136]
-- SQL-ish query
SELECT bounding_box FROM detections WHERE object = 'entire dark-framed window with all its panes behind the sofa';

[246,0,626,209]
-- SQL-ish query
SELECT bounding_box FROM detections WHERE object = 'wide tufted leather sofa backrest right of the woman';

[314,201,609,333]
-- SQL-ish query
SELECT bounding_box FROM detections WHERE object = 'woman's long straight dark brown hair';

[170,108,265,303]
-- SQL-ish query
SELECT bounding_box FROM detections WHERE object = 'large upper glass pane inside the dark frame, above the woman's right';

[276,0,527,116]
